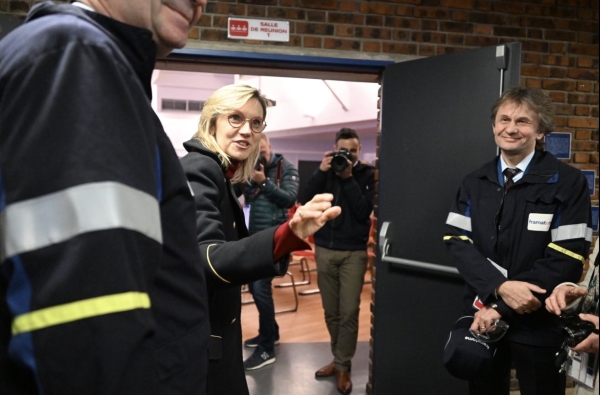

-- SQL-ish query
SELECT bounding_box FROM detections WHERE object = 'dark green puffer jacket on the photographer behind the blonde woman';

[236,154,300,233]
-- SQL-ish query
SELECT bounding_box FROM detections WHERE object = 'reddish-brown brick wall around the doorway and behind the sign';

[0,0,599,390]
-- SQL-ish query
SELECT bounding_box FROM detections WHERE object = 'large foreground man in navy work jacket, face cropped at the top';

[0,0,210,395]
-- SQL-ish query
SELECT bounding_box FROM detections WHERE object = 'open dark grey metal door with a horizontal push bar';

[372,43,521,395]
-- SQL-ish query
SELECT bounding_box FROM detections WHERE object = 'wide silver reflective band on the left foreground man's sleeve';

[0,181,162,263]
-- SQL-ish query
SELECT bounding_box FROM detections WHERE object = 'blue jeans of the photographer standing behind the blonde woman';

[248,277,279,352]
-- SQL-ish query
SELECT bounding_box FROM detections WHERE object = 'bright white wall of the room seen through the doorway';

[152,70,379,165]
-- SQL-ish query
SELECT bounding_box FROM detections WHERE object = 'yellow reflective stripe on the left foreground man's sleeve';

[12,292,150,335]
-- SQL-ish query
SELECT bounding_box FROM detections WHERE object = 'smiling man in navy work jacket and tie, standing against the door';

[444,87,592,395]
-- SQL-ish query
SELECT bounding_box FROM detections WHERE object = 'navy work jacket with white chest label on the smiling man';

[444,151,592,346]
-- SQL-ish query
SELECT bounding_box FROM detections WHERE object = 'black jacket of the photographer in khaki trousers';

[301,162,375,251]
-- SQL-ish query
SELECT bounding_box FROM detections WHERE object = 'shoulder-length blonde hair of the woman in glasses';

[192,84,268,184]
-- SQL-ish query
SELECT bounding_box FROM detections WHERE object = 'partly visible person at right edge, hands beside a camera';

[546,240,600,395]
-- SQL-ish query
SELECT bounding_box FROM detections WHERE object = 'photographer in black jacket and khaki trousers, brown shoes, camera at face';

[302,128,375,394]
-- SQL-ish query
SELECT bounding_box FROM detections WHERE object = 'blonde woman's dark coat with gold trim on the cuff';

[181,140,289,395]
